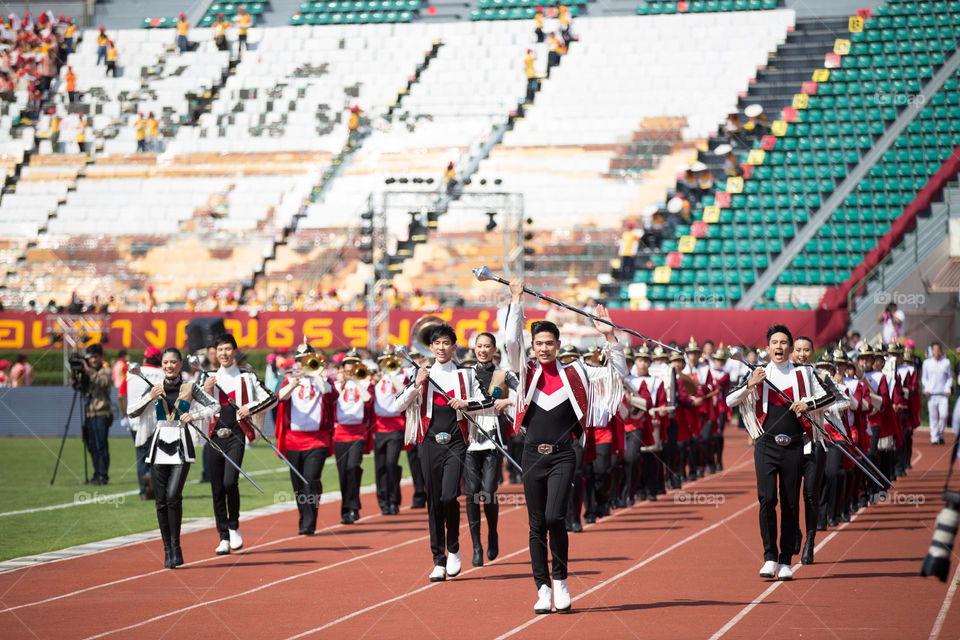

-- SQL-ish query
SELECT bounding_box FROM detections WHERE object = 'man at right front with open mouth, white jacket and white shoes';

[727,324,834,580]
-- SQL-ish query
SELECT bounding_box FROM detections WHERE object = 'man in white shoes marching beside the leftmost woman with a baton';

[204,333,277,555]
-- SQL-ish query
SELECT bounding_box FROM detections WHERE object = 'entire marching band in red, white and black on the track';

[129,272,921,613]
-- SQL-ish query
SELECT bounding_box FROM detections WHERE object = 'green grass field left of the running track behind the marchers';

[0,437,409,560]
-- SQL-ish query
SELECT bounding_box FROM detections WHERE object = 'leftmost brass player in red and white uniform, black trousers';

[277,341,336,536]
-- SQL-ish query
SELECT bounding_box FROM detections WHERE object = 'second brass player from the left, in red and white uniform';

[333,349,373,524]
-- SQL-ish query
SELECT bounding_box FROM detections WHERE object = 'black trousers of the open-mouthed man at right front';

[753,436,803,564]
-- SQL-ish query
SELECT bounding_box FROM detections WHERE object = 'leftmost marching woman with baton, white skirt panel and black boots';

[147,348,217,569]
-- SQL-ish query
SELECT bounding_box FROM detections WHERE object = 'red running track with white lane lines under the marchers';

[0,432,960,640]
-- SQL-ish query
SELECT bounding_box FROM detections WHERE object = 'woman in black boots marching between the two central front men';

[463,333,519,567]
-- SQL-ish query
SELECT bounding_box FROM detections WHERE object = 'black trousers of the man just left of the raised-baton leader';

[420,428,467,566]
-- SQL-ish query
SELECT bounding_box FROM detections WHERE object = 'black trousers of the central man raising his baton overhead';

[521,445,577,589]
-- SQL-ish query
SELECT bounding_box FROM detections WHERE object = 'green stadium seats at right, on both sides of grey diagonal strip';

[621,2,960,307]
